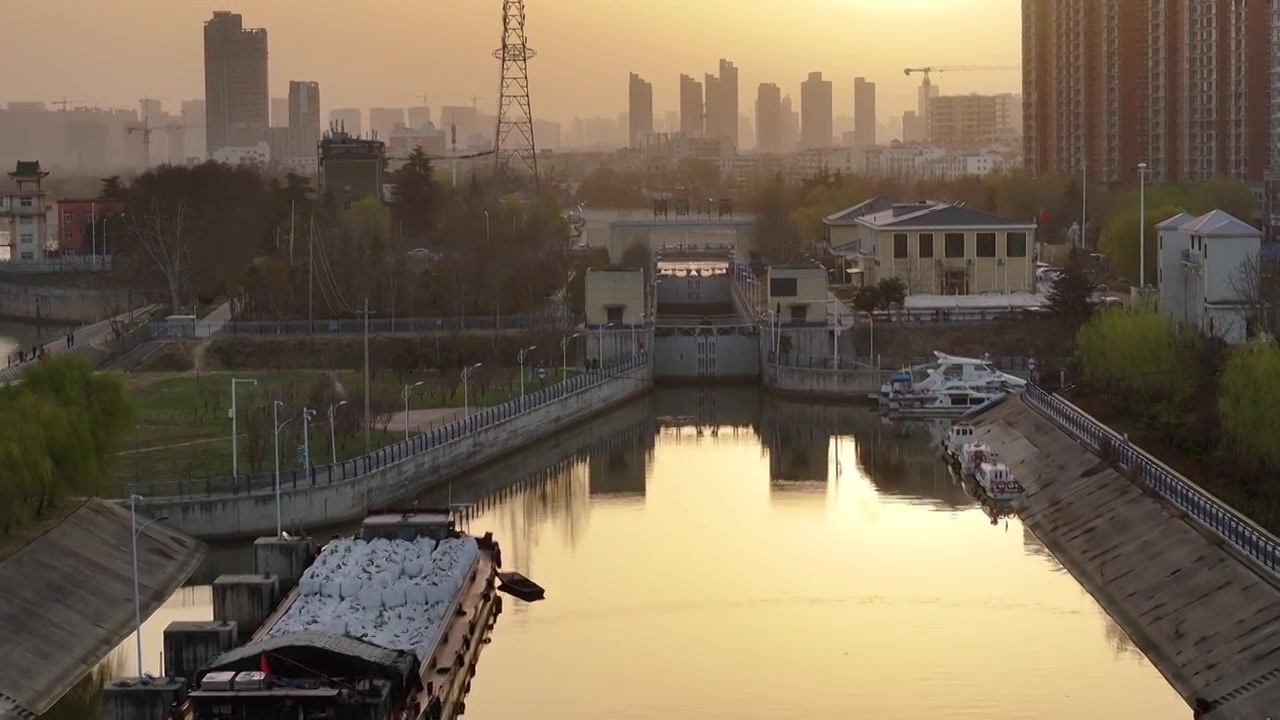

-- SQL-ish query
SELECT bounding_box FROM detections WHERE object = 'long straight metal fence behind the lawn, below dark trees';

[147,314,576,338]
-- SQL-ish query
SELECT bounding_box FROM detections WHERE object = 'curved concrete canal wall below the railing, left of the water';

[138,364,653,539]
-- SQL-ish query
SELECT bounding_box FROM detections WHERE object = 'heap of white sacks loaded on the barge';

[268,537,480,660]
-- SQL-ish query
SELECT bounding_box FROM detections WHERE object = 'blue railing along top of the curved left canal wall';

[137,354,649,500]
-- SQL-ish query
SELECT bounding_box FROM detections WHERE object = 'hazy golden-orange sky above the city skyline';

[0,0,1020,120]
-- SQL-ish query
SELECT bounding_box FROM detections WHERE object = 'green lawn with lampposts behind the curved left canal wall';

[104,368,576,486]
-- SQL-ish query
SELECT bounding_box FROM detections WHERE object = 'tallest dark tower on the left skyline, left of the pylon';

[205,10,270,154]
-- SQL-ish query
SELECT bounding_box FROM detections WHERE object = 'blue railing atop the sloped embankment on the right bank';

[1024,386,1280,573]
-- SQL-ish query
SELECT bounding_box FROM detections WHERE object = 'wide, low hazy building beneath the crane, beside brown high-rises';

[925,92,1021,150]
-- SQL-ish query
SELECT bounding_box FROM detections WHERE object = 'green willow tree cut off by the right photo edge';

[1217,341,1280,470]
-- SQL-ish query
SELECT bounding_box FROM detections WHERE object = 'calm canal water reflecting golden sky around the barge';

[119,389,1189,720]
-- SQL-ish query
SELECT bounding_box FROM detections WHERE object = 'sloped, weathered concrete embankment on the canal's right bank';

[978,397,1280,720]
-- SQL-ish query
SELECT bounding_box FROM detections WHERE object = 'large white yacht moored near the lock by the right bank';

[872,351,1027,418]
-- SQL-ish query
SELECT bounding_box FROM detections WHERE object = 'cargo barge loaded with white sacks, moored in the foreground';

[184,509,502,720]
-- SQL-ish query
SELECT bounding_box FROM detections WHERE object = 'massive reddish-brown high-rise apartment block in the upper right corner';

[1023,0,1272,182]
